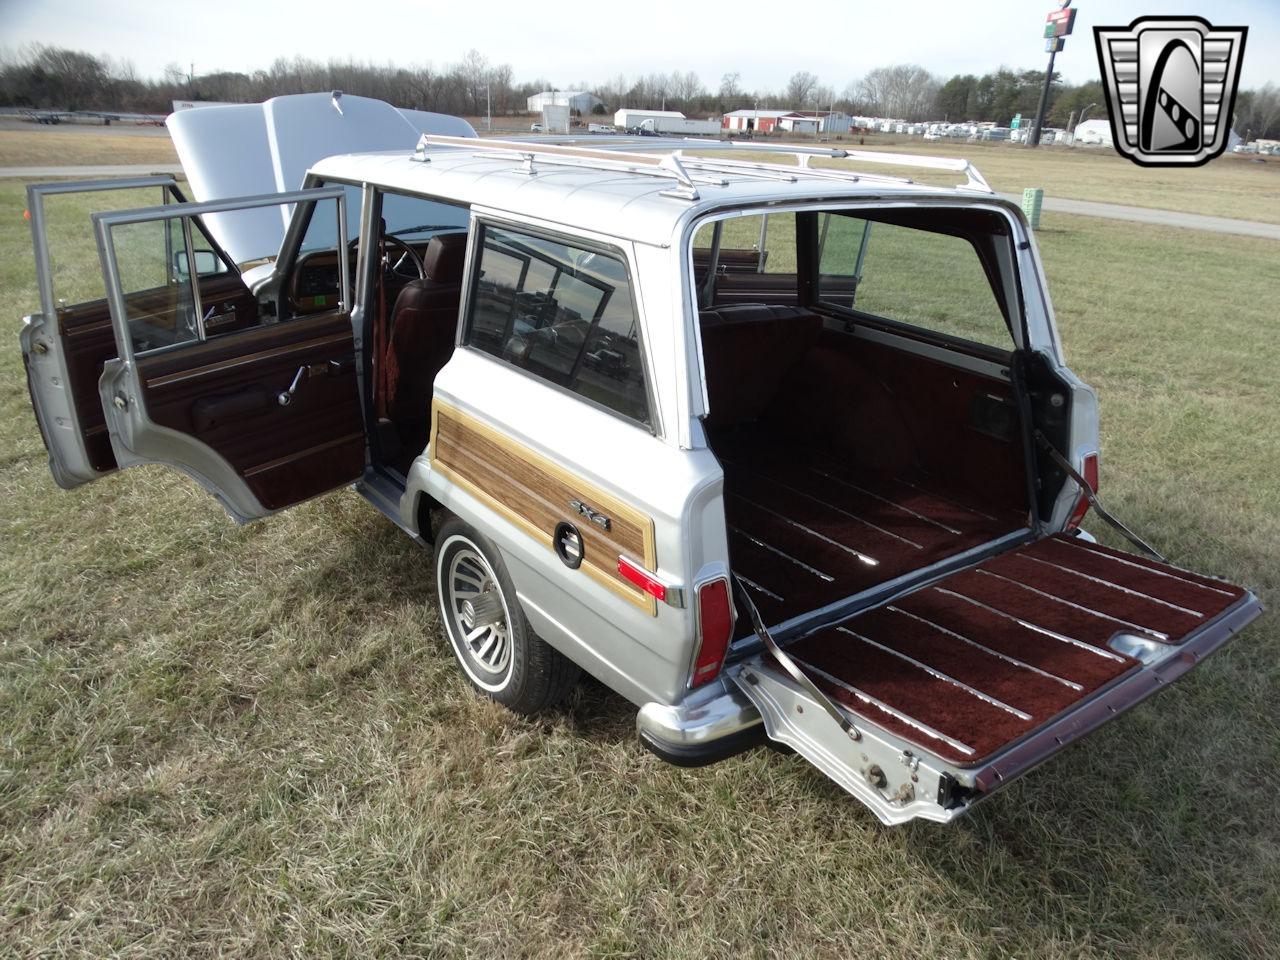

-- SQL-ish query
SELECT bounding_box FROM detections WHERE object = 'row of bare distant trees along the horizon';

[0,46,1280,137]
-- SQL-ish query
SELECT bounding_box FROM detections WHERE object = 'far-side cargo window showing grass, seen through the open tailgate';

[818,214,1014,349]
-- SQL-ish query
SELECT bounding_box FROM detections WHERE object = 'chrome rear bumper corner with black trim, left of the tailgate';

[636,676,765,767]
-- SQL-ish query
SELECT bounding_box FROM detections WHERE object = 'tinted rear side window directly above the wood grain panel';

[465,227,652,425]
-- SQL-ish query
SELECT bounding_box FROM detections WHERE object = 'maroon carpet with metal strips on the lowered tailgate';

[786,535,1244,765]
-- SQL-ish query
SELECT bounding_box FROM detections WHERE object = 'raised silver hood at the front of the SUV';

[165,93,476,264]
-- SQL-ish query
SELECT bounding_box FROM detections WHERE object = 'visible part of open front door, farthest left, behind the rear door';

[20,177,184,489]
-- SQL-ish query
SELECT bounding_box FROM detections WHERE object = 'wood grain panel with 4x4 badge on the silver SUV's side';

[429,403,657,614]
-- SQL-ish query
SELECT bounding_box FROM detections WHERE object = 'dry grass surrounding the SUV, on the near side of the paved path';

[0,182,1280,959]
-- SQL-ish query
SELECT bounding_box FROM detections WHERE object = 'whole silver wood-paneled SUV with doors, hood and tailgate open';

[22,95,1261,823]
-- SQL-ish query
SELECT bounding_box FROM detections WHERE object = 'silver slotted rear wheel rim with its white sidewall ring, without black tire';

[440,544,511,691]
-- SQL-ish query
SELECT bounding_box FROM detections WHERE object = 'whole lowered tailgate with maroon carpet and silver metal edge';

[732,535,1262,823]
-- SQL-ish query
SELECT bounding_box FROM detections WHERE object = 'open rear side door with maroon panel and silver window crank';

[93,188,365,521]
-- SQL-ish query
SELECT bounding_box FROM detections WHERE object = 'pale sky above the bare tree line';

[0,0,1280,92]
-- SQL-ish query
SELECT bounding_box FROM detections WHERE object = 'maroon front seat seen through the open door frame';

[384,233,467,457]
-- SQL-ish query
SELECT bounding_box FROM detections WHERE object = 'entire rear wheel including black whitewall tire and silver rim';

[435,517,580,716]
